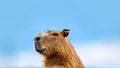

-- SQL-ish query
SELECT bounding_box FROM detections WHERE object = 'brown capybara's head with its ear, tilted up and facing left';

[34,29,70,56]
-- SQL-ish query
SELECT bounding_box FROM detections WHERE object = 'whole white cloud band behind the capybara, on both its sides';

[0,41,120,67]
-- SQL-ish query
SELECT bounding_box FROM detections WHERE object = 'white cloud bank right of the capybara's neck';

[75,42,120,67]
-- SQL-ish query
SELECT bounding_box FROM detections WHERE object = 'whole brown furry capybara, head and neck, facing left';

[35,29,84,68]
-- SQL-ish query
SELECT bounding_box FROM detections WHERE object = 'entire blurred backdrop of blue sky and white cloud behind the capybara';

[0,0,120,68]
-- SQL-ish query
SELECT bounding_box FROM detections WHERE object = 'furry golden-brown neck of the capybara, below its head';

[44,38,84,68]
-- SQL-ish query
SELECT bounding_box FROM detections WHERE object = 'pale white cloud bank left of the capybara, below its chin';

[0,51,43,68]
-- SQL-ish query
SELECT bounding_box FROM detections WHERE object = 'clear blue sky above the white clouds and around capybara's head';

[0,0,120,67]
